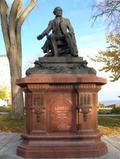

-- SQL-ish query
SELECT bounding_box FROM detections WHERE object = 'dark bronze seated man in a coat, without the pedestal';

[37,7,78,57]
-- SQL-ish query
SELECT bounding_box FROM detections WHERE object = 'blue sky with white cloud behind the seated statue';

[0,0,120,101]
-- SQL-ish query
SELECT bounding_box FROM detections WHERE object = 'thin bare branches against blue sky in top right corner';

[93,0,120,33]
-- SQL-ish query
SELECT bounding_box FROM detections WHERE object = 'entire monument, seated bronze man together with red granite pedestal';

[16,7,107,159]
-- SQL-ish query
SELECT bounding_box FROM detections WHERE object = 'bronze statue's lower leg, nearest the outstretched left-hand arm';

[50,34,58,56]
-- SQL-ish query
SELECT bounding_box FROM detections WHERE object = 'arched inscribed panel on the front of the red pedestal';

[50,99,73,131]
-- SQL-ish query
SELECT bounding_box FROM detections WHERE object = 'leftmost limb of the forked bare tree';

[0,0,10,54]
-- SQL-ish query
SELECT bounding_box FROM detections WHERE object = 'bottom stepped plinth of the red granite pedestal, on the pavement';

[17,134,107,159]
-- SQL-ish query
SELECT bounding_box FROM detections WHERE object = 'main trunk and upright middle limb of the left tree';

[8,0,24,118]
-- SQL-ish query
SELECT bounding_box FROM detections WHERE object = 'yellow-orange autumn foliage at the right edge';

[92,34,120,81]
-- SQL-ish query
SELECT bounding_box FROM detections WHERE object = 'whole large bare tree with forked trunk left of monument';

[0,0,37,117]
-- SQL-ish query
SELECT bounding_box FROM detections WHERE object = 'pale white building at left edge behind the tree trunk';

[0,55,10,88]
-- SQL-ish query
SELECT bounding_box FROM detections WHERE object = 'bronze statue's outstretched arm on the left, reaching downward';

[37,21,52,40]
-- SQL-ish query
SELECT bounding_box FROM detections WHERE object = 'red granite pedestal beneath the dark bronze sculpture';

[17,74,107,159]
